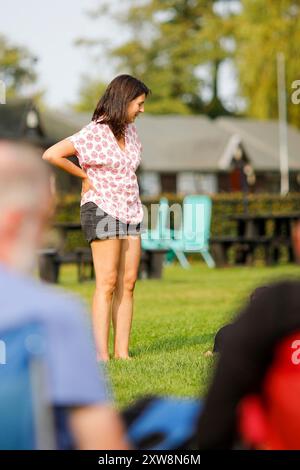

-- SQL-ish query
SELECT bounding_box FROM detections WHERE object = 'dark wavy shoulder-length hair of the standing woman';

[92,75,151,139]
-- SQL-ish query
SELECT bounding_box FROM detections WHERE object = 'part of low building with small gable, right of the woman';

[137,116,300,195]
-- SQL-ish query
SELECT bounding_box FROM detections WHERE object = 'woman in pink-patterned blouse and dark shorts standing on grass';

[43,75,150,361]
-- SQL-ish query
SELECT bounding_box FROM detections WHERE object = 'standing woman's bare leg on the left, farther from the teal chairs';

[91,238,123,361]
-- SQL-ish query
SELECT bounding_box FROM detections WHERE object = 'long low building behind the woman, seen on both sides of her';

[0,100,300,197]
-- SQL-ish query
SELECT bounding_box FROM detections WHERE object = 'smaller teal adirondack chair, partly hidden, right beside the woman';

[141,197,171,250]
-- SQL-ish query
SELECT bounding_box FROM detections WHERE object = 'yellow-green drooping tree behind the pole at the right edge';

[232,0,300,127]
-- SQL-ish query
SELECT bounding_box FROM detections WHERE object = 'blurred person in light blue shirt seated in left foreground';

[0,140,128,449]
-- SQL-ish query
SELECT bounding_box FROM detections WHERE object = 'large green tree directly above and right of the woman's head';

[78,0,237,116]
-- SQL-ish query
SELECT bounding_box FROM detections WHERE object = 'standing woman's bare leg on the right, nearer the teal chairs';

[112,236,141,359]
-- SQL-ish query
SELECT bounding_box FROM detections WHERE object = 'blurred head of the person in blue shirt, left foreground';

[0,140,54,273]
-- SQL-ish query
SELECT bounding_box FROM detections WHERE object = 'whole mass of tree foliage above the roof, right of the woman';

[75,0,300,127]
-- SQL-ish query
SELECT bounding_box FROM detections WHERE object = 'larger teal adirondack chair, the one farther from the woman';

[169,195,215,268]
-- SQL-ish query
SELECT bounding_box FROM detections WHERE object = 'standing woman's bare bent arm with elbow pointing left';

[42,139,87,180]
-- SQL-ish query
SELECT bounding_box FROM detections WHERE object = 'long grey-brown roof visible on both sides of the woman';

[0,100,300,172]
